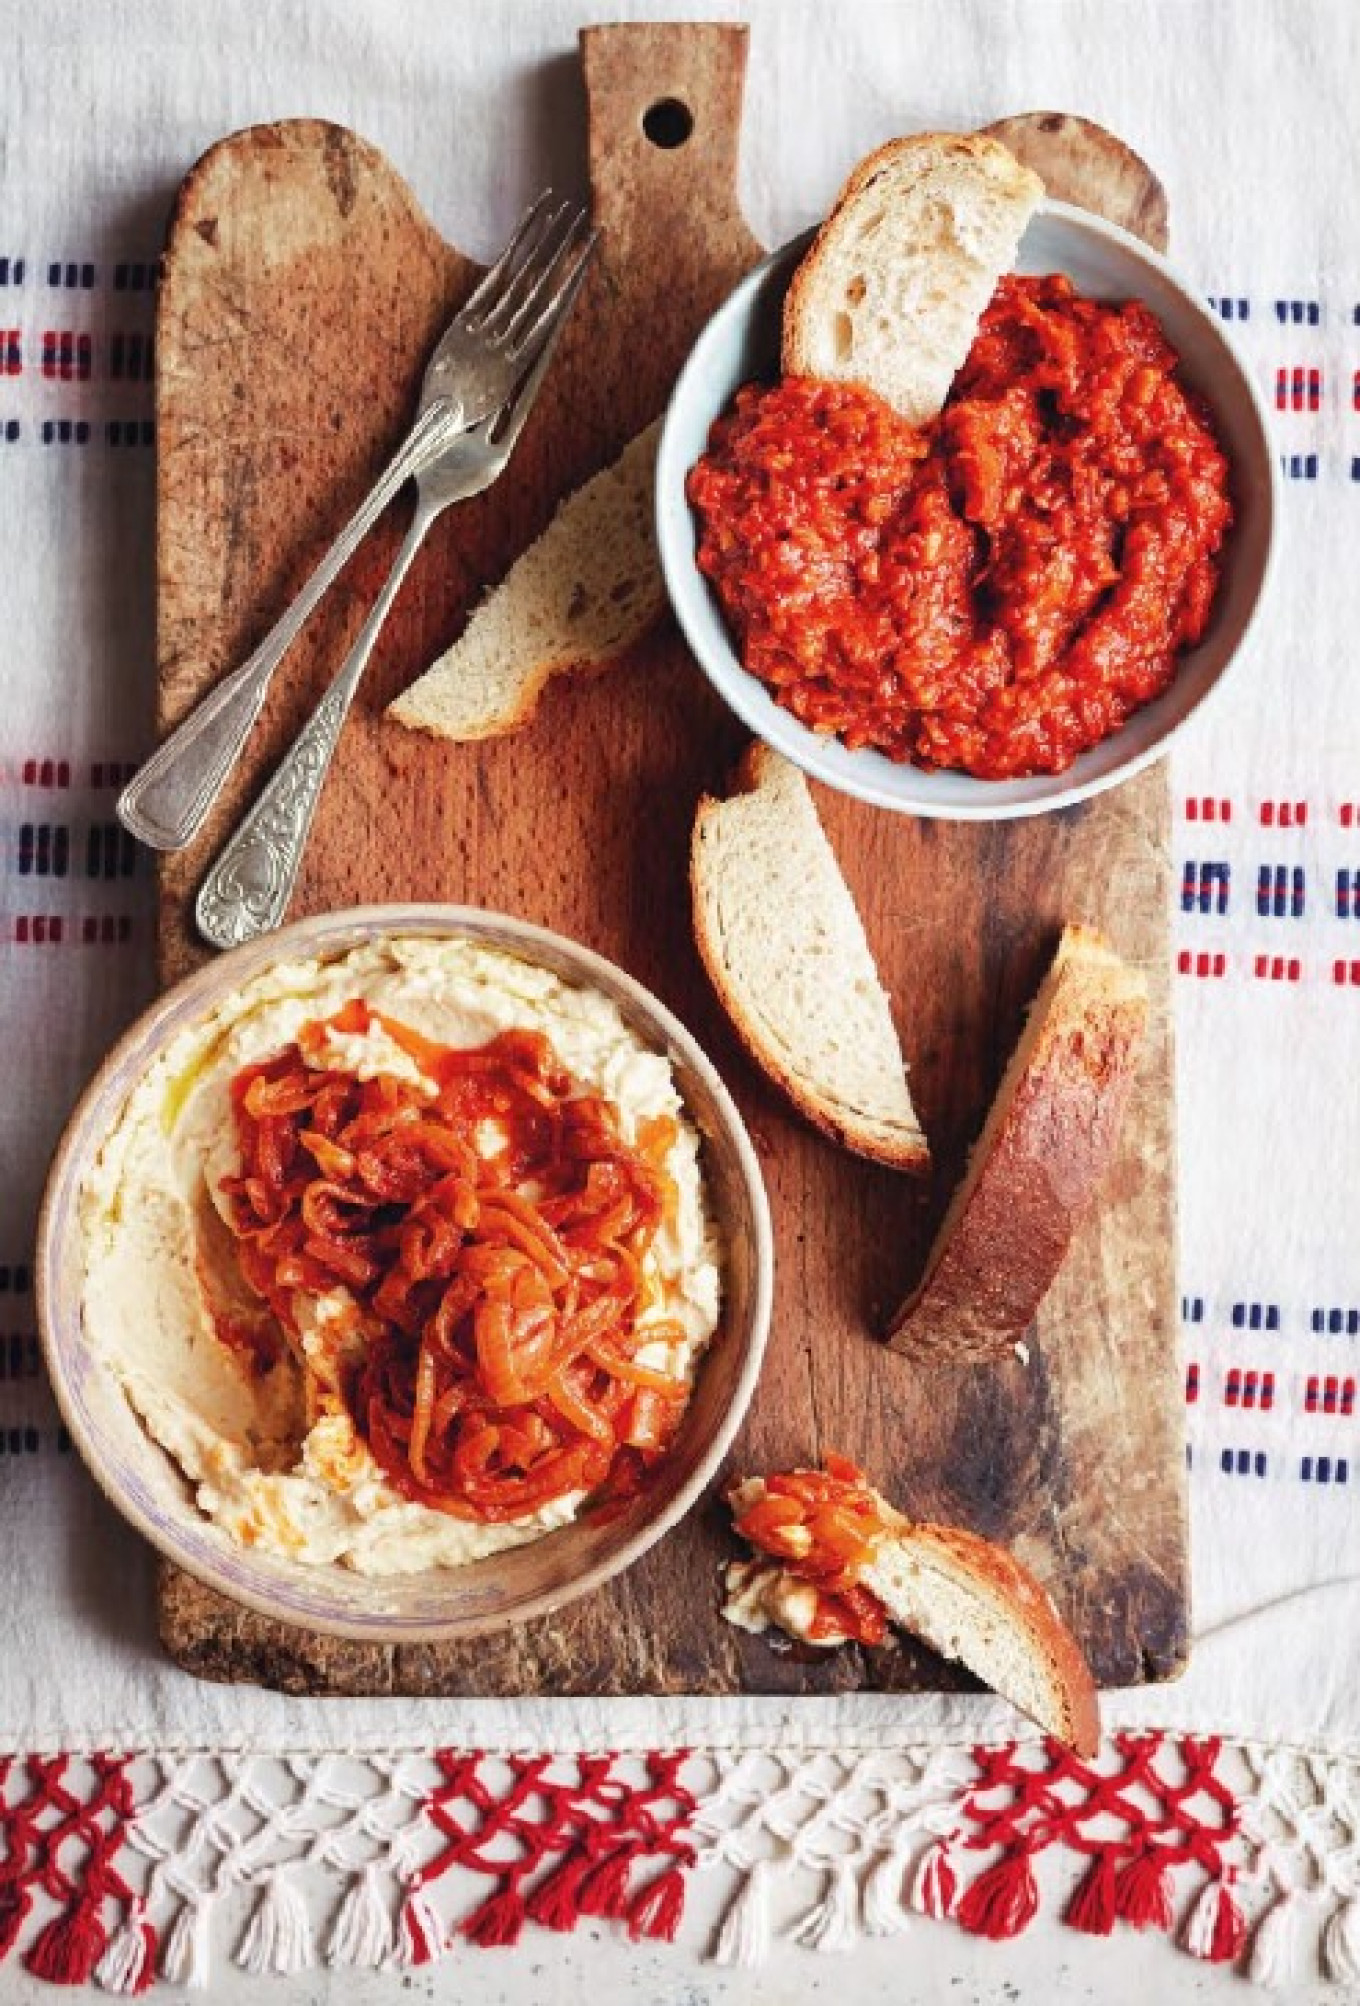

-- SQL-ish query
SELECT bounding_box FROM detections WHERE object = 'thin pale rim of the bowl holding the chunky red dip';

[654,199,1282,822]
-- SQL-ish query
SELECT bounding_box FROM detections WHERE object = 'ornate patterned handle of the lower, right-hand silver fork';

[195,502,439,947]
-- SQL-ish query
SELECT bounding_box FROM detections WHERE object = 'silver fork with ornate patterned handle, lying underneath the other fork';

[195,233,596,947]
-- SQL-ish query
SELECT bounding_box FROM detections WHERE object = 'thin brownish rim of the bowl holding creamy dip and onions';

[34,903,774,1645]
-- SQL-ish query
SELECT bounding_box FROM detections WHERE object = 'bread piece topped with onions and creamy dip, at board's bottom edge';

[722,1456,1099,1755]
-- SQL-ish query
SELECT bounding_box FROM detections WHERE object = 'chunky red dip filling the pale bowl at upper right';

[688,275,1232,780]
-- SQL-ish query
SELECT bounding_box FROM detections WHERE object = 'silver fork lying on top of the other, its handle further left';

[118,189,594,851]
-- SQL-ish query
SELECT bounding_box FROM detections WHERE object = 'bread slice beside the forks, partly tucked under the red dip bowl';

[387,419,666,740]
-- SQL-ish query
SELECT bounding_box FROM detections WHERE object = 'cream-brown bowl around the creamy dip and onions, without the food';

[36,905,774,1645]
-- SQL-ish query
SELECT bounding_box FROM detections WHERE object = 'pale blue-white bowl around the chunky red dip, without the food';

[656,203,1278,820]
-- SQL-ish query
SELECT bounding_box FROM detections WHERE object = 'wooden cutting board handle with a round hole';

[580,22,748,251]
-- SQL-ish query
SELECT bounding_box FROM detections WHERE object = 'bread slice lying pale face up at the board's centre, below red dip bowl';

[690,740,931,1172]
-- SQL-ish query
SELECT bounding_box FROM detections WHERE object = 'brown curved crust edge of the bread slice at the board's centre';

[690,738,931,1178]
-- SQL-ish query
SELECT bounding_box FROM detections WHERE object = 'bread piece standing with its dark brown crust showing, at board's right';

[889,925,1147,1364]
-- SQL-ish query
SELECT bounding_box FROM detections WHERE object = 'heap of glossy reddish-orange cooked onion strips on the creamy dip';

[223,1001,690,1523]
